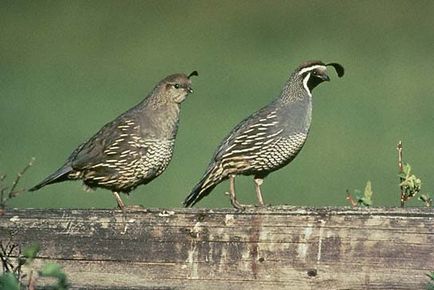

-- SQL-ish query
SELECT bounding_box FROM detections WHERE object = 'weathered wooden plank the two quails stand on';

[0,206,434,289]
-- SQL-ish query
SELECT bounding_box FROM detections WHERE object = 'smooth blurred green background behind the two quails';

[0,0,434,208]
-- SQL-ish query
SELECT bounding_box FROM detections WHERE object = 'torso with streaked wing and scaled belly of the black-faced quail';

[209,97,311,172]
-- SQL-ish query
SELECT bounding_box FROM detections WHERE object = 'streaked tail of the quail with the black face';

[183,166,225,207]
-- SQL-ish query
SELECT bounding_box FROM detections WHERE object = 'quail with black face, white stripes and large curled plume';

[184,61,344,208]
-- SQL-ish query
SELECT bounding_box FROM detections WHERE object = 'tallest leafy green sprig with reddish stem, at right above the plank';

[396,141,432,207]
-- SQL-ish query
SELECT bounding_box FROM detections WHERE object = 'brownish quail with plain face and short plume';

[30,71,198,210]
